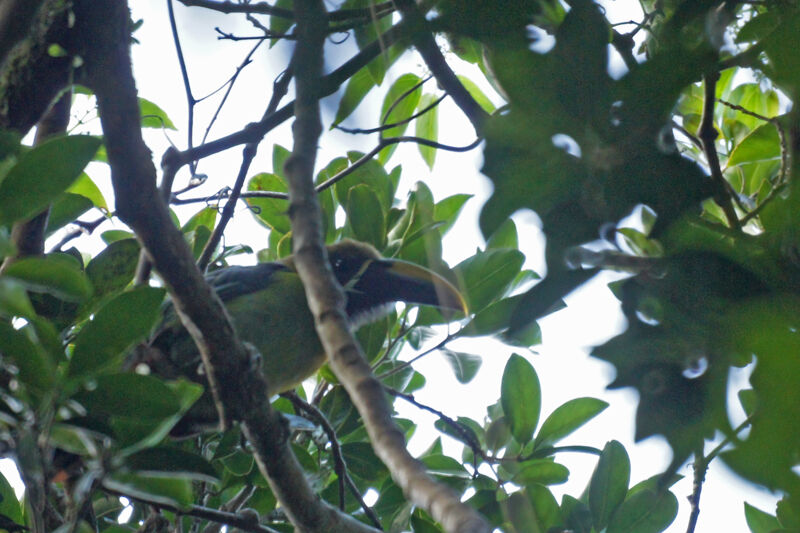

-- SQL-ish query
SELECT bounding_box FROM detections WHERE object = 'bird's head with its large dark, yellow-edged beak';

[294,239,467,326]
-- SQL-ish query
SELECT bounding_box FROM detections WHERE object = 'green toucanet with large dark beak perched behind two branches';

[149,239,468,426]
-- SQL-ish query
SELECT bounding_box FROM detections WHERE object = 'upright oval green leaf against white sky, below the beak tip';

[500,354,542,445]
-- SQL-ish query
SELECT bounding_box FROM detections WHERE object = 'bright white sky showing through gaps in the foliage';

[0,0,775,533]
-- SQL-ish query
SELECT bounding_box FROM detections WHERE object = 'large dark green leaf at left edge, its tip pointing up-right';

[0,135,100,225]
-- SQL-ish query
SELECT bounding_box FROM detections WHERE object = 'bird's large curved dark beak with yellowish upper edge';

[374,259,469,318]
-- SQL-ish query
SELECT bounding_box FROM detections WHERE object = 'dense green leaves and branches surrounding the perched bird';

[0,0,800,533]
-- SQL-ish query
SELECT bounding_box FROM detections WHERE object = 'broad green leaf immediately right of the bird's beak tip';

[453,249,525,311]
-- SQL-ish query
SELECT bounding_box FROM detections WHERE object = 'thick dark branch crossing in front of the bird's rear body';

[73,0,375,533]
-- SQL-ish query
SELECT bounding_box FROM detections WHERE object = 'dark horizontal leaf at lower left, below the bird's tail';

[123,446,219,483]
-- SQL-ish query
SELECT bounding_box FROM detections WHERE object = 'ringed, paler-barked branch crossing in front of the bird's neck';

[285,0,490,533]
